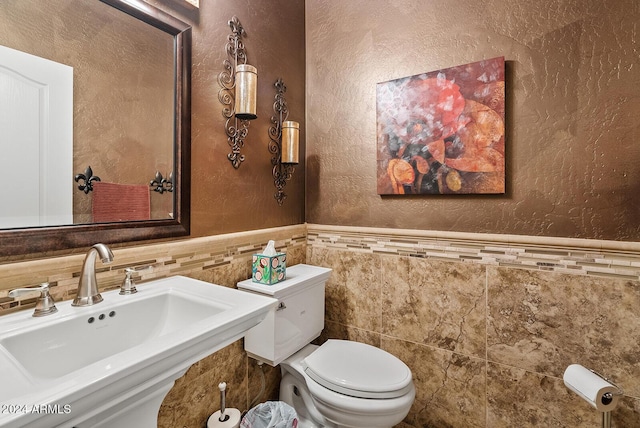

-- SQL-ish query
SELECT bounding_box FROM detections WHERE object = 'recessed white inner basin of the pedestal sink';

[0,289,230,378]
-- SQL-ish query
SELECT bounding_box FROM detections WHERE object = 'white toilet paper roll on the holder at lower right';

[563,364,619,412]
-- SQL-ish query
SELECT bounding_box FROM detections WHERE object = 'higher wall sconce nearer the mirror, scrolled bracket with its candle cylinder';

[218,16,258,169]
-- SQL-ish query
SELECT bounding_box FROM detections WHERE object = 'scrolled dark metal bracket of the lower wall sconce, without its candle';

[269,79,295,205]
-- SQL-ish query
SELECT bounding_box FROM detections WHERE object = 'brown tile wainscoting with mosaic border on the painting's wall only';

[307,225,640,428]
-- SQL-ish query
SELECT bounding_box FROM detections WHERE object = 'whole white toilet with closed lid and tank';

[238,264,415,428]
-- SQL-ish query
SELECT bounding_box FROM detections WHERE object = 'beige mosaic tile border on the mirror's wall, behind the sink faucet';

[0,224,307,315]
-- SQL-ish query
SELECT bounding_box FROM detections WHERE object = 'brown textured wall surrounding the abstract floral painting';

[306,0,640,241]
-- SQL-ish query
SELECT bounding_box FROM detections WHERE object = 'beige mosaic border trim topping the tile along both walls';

[0,224,640,315]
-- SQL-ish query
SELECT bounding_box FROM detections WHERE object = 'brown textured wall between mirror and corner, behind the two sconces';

[149,0,306,236]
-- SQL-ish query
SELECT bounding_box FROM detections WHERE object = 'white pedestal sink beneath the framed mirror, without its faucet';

[0,276,277,428]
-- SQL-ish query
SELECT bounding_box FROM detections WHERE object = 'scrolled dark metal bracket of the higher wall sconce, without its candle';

[218,16,250,169]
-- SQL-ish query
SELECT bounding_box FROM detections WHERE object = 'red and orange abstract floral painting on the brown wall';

[376,57,505,195]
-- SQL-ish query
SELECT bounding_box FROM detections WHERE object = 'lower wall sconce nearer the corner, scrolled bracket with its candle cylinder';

[269,79,300,205]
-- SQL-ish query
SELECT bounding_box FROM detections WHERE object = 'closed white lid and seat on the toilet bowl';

[303,340,412,398]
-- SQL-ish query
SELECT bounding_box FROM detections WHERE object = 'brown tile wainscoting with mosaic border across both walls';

[0,224,640,428]
